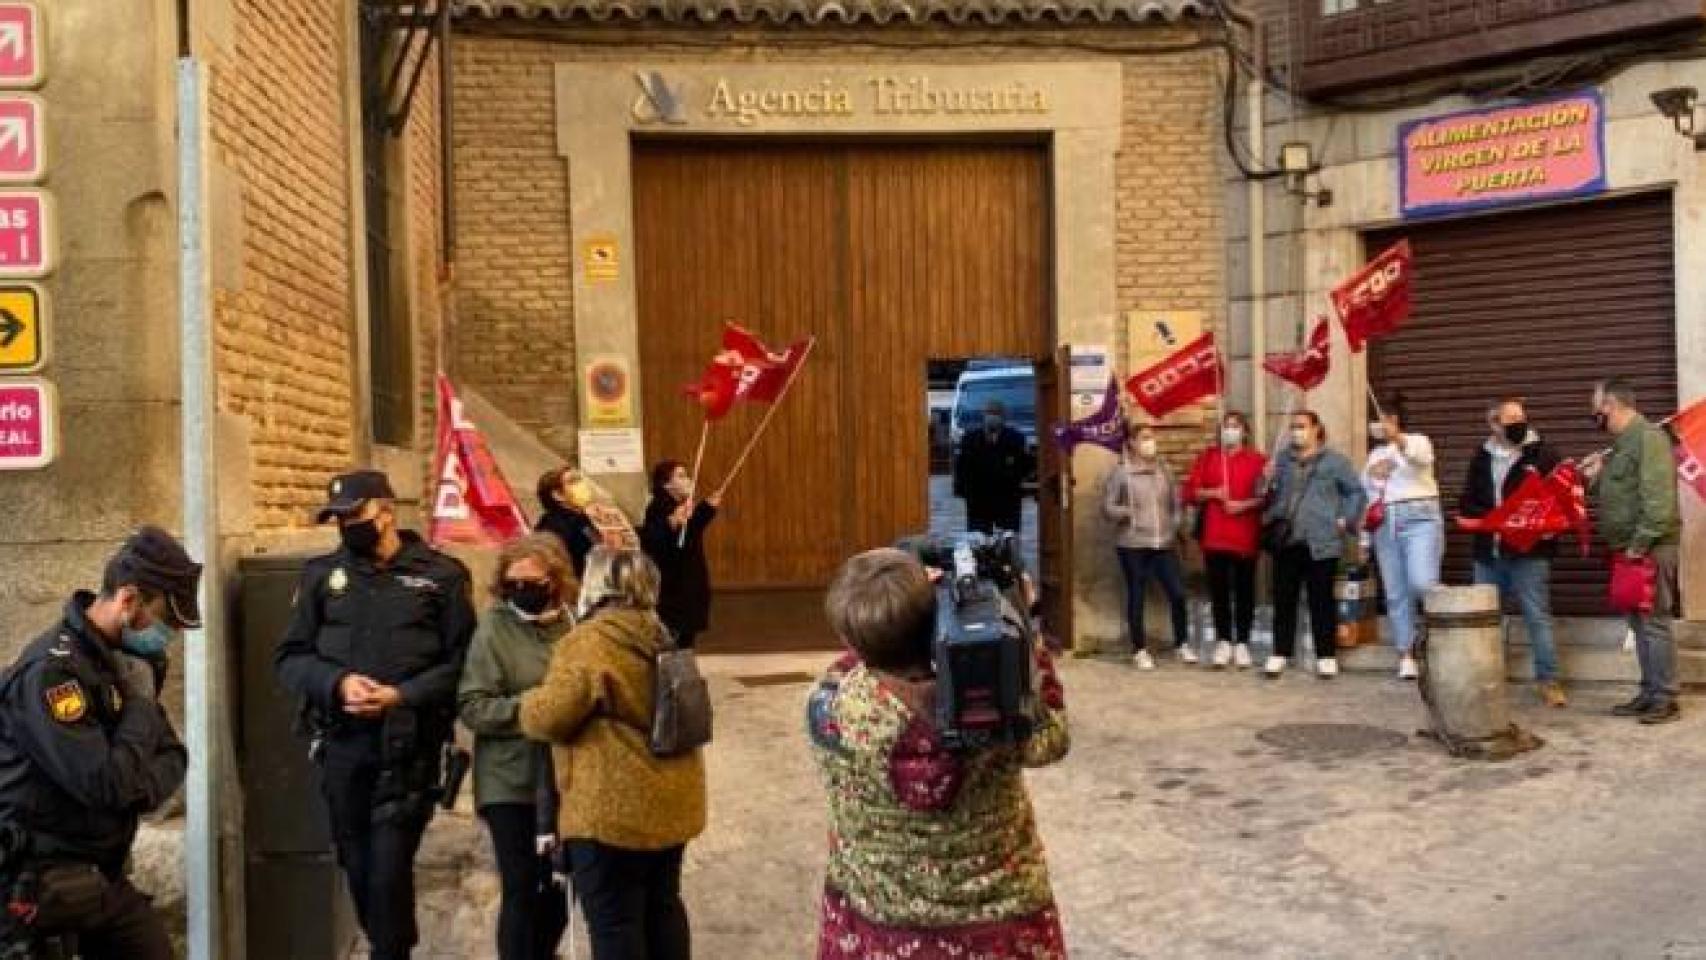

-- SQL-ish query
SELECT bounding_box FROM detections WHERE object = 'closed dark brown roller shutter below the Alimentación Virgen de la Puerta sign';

[1367,193,1677,616]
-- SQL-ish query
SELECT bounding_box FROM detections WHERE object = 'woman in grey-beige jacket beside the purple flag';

[1102,426,1198,670]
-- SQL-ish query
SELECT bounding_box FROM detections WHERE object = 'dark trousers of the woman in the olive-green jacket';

[479,803,568,960]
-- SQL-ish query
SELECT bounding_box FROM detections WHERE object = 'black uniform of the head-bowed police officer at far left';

[0,592,189,960]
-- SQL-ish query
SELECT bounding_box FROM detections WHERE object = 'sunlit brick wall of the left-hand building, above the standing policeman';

[208,0,442,534]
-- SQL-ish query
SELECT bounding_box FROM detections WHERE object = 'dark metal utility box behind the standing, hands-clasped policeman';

[235,554,357,960]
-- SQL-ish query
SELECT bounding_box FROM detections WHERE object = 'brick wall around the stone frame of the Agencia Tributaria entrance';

[454,20,1225,454]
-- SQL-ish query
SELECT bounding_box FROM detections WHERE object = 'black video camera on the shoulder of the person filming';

[899,534,1037,750]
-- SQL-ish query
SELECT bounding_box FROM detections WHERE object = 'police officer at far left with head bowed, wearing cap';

[0,527,201,960]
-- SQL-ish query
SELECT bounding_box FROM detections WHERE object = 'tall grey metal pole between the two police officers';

[177,56,225,960]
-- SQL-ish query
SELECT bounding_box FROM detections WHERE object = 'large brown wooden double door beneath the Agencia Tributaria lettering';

[633,140,1058,646]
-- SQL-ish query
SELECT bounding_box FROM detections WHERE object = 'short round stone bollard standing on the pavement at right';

[1418,585,1541,759]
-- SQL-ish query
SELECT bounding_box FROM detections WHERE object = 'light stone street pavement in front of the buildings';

[392,655,1706,960]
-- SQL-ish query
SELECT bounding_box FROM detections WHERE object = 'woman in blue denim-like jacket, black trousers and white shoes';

[1262,411,1368,677]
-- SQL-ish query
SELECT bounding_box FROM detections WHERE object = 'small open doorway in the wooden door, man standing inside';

[925,356,1047,578]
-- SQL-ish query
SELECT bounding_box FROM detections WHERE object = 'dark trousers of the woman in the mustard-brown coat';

[568,841,693,960]
